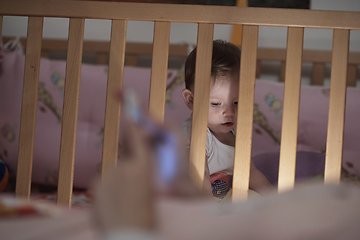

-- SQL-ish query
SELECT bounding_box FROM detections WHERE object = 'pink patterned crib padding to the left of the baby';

[0,52,178,188]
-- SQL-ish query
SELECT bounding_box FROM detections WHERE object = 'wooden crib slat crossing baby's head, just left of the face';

[189,23,214,189]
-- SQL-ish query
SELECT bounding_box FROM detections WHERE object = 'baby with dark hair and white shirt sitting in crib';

[182,40,274,198]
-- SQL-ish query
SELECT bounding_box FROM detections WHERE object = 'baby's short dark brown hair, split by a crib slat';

[185,40,241,90]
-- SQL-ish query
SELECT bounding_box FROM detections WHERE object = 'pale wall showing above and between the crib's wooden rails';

[3,0,360,51]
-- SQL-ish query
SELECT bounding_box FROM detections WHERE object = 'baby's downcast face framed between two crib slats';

[208,75,239,135]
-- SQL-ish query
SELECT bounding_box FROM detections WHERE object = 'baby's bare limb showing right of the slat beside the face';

[249,160,275,195]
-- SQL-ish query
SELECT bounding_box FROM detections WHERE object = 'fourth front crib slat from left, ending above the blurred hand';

[149,22,170,123]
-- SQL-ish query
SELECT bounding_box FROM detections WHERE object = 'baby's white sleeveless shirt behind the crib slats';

[182,117,235,175]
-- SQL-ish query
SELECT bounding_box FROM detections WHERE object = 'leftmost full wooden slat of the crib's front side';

[16,17,44,199]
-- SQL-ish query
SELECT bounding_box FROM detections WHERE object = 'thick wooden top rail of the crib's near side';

[0,0,360,30]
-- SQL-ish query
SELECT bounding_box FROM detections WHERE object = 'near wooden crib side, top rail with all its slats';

[0,0,360,205]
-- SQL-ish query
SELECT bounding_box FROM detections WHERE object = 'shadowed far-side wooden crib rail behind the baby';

[3,37,360,87]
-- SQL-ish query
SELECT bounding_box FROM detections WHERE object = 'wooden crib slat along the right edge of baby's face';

[232,25,259,200]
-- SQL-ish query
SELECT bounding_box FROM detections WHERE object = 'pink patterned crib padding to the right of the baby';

[252,80,360,175]
